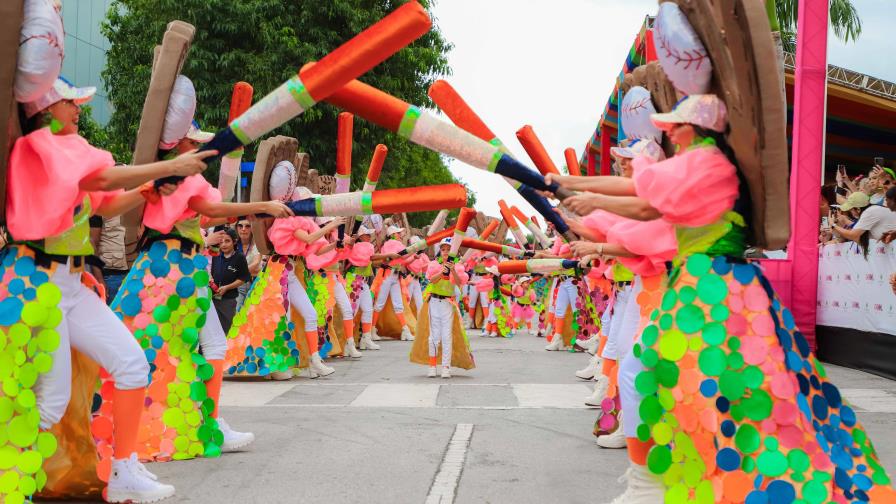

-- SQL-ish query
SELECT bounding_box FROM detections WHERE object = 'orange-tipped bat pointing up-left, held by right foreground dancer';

[322,79,572,199]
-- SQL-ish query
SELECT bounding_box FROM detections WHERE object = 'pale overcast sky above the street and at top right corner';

[433,0,896,226]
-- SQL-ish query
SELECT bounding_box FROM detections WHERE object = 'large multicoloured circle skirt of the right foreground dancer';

[633,254,896,504]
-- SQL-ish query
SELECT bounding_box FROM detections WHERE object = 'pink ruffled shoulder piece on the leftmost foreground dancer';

[6,128,115,240]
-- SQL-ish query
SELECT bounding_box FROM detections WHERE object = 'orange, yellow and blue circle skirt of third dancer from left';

[225,256,299,377]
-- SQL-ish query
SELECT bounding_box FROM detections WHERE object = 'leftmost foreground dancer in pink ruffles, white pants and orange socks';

[6,79,214,502]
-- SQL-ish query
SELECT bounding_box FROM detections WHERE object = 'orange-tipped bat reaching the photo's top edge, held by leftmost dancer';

[197,1,432,161]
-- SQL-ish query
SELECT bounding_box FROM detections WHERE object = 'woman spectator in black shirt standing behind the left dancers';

[212,228,251,333]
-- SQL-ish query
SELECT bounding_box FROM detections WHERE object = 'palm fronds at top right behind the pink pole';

[766,0,862,52]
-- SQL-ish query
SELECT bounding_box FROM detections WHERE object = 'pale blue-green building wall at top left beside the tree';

[62,0,112,124]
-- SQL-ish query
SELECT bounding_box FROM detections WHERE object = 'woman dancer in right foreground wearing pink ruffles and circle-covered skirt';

[548,95,896,502]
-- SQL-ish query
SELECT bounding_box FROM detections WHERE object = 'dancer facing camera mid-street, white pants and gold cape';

[411,238,476,378]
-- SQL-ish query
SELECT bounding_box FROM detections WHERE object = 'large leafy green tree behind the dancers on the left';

[103,0,462,225]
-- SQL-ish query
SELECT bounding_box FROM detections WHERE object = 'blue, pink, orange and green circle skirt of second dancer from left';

[107,240,223,460]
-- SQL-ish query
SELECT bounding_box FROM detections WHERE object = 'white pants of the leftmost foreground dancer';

[35,265,149,429]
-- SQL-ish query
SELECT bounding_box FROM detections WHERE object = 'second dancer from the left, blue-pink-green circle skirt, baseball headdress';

[111,88,291,460]
